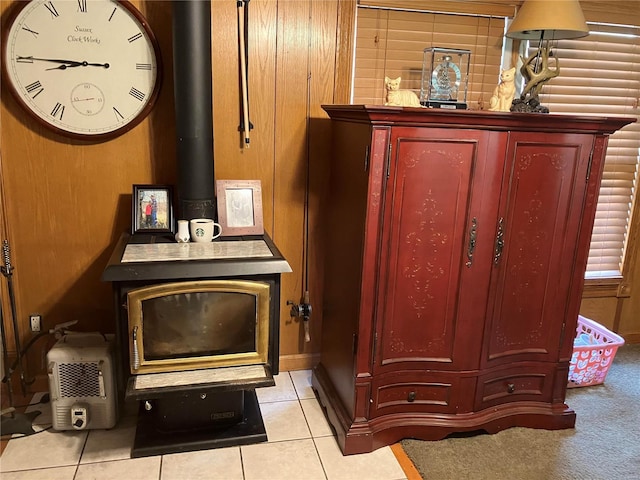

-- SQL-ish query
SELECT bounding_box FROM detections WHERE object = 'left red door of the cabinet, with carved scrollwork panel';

[376,128,504,372]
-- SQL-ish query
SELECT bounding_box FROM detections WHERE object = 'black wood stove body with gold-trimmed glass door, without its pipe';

[102,234,291,457]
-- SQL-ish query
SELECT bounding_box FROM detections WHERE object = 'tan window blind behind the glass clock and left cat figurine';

[352,6,505,109]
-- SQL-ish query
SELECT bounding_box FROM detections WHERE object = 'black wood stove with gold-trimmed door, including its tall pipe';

[102,0,291,457]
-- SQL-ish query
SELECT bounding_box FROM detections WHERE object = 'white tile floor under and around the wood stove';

[0,370,406,480]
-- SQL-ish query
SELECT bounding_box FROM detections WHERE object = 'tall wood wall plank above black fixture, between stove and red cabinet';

[273,0,311,356]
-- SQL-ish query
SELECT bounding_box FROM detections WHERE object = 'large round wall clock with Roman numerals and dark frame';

[2,0,162,141]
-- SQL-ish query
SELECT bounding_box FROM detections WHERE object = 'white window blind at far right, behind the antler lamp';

[527,24,640,278]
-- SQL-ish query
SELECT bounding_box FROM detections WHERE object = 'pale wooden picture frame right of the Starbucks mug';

[216,180,264,237]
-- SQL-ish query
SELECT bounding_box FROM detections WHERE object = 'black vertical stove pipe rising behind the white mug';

[173,0,216,220]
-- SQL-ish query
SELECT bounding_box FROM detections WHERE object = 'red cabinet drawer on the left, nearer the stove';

[370,372,475,417]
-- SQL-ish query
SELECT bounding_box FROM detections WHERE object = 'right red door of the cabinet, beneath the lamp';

[484,133,592,364]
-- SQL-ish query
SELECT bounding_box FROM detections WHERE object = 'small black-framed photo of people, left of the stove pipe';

[131,185,174,234]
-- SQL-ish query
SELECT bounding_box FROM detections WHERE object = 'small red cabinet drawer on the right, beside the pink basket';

[475,364,555,410]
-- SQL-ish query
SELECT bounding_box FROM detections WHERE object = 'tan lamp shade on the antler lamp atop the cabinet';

[507,0,589,40]
